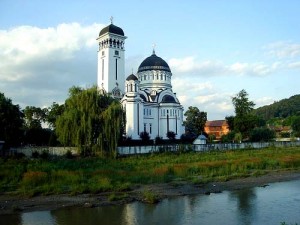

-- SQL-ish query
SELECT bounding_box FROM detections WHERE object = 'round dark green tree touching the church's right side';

[183,106,207,135]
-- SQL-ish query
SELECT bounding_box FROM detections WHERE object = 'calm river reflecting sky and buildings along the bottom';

[0,180,300,225]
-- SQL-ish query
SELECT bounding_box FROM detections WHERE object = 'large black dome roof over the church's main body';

[138,51,171,72]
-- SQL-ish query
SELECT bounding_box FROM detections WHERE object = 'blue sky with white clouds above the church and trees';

[0,0,300,120]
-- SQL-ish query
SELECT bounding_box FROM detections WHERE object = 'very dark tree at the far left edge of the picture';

[0,92,23,146]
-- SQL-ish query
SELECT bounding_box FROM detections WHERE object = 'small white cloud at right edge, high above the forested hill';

[263,41,300,58]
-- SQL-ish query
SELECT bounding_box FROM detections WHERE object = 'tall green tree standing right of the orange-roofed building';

[232,90,259,138]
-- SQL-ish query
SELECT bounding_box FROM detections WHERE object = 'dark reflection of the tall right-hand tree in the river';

[229,189,257,225]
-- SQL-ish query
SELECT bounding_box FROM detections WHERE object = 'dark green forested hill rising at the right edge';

[254,95,300,120]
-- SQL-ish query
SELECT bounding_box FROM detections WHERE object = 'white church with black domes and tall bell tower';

[97,22,184,140]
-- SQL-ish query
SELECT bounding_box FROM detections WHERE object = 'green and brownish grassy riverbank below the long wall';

[0,147,300,196]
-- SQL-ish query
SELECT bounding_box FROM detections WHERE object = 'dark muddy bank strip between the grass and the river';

[0,171,300,214]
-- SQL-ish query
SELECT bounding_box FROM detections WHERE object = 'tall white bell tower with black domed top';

[97,17,127,99]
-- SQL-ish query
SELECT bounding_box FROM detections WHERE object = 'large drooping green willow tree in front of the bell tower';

[56,86,123,155]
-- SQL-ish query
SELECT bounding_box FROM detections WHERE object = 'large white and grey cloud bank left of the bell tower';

[0,23,103,107]
